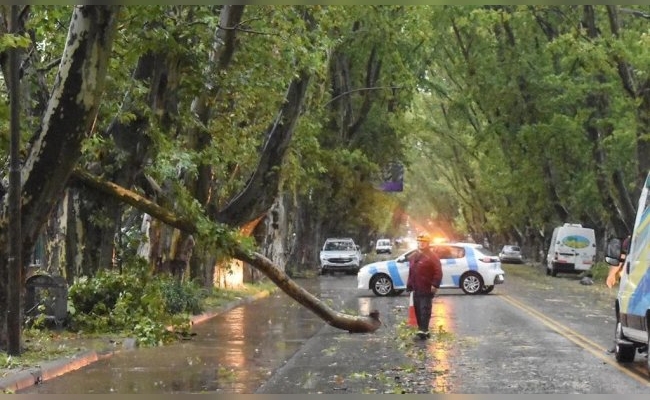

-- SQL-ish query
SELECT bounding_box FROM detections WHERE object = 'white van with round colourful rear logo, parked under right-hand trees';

[546,223,596,276]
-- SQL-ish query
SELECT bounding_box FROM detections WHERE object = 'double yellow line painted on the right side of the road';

[499,295,650,386]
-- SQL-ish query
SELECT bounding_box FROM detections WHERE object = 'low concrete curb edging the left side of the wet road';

[0,291,270,393]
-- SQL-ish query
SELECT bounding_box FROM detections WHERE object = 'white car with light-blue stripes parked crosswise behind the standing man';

[357,243,505,296]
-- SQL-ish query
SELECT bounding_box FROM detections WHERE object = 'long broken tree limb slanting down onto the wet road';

[74,169,381,332]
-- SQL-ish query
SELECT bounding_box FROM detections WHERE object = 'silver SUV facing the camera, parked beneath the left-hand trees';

[319,238,362,275]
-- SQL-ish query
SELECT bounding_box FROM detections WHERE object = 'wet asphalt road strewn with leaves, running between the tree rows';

[20,266,650,394]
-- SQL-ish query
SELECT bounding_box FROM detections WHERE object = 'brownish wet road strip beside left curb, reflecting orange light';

[20,280,323,394]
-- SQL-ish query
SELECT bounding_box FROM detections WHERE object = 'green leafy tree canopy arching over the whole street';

[0,5,650,346]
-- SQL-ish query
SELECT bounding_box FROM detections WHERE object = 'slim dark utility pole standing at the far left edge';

[7,5,23,356]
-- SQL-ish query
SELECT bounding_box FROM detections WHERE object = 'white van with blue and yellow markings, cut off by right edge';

[605,173,650,372]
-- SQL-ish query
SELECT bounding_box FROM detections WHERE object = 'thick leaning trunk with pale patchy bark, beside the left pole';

[0,5,120,346]
